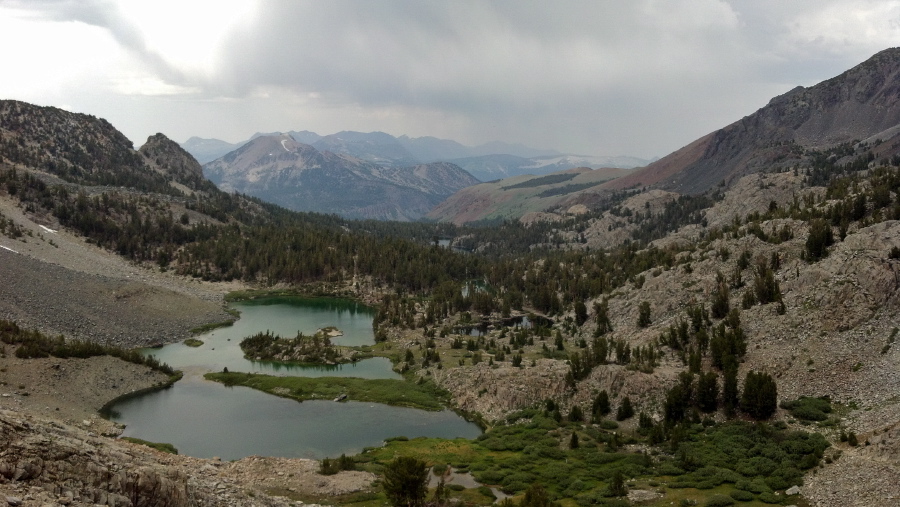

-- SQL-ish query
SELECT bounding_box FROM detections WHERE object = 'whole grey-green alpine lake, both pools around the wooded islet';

[104,297,481,460]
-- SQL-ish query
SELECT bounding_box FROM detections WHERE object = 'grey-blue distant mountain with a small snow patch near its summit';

[204,135,478,221]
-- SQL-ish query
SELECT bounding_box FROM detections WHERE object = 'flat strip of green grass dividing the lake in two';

[204,372,447,411]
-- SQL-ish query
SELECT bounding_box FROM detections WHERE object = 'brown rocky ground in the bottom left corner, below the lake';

[0,410,375,507]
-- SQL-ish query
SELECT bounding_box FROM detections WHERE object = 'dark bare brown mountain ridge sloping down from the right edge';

[606,48,900,194]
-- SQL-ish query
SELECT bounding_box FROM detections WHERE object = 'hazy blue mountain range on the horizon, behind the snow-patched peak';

[181,131,650,181]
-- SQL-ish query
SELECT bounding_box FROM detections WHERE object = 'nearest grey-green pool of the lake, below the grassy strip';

[111,377,481,460]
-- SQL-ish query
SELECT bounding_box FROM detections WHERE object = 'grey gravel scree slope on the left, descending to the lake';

[0,192,240,347]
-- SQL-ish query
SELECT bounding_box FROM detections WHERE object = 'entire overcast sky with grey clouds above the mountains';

[0,0,900,158]
